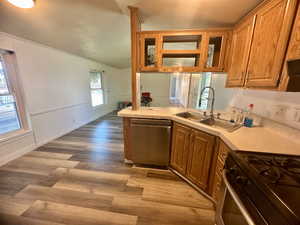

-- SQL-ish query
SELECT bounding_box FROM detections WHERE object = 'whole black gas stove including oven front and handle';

[217,151,300,225]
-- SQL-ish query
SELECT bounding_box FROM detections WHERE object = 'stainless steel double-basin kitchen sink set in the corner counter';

[176,112,242,132]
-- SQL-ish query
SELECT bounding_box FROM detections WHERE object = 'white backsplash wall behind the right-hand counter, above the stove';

[230,90,300,129]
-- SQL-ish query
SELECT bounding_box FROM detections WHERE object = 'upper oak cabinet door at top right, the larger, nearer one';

[246,0,297,88]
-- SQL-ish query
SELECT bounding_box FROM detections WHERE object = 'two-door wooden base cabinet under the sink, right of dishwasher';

[170,123,215,191]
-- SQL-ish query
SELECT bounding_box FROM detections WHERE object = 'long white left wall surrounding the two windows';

[0,33,121,164]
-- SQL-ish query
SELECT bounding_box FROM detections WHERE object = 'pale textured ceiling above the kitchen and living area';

[0,0,261,68]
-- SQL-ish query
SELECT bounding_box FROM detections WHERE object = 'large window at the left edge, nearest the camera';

[0,51,25,135]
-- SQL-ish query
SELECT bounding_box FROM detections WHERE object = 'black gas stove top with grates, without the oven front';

[227,151,300,224]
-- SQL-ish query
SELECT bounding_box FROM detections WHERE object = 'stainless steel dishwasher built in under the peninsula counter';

[131,119,172,166]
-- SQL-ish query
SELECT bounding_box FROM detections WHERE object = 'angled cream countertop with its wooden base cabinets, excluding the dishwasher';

[118,107,300,200]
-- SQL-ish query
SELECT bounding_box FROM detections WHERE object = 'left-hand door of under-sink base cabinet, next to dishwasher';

[171,123,191,175]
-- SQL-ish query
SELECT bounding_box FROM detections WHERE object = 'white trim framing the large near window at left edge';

[0,50,32,139]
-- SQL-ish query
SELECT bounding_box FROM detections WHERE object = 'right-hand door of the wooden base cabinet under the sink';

[186,130,215,190]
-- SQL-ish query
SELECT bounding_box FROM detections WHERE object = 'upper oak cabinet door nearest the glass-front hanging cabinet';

[226,16,256,87]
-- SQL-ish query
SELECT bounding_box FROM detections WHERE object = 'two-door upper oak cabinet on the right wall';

[226,0,300,91]
